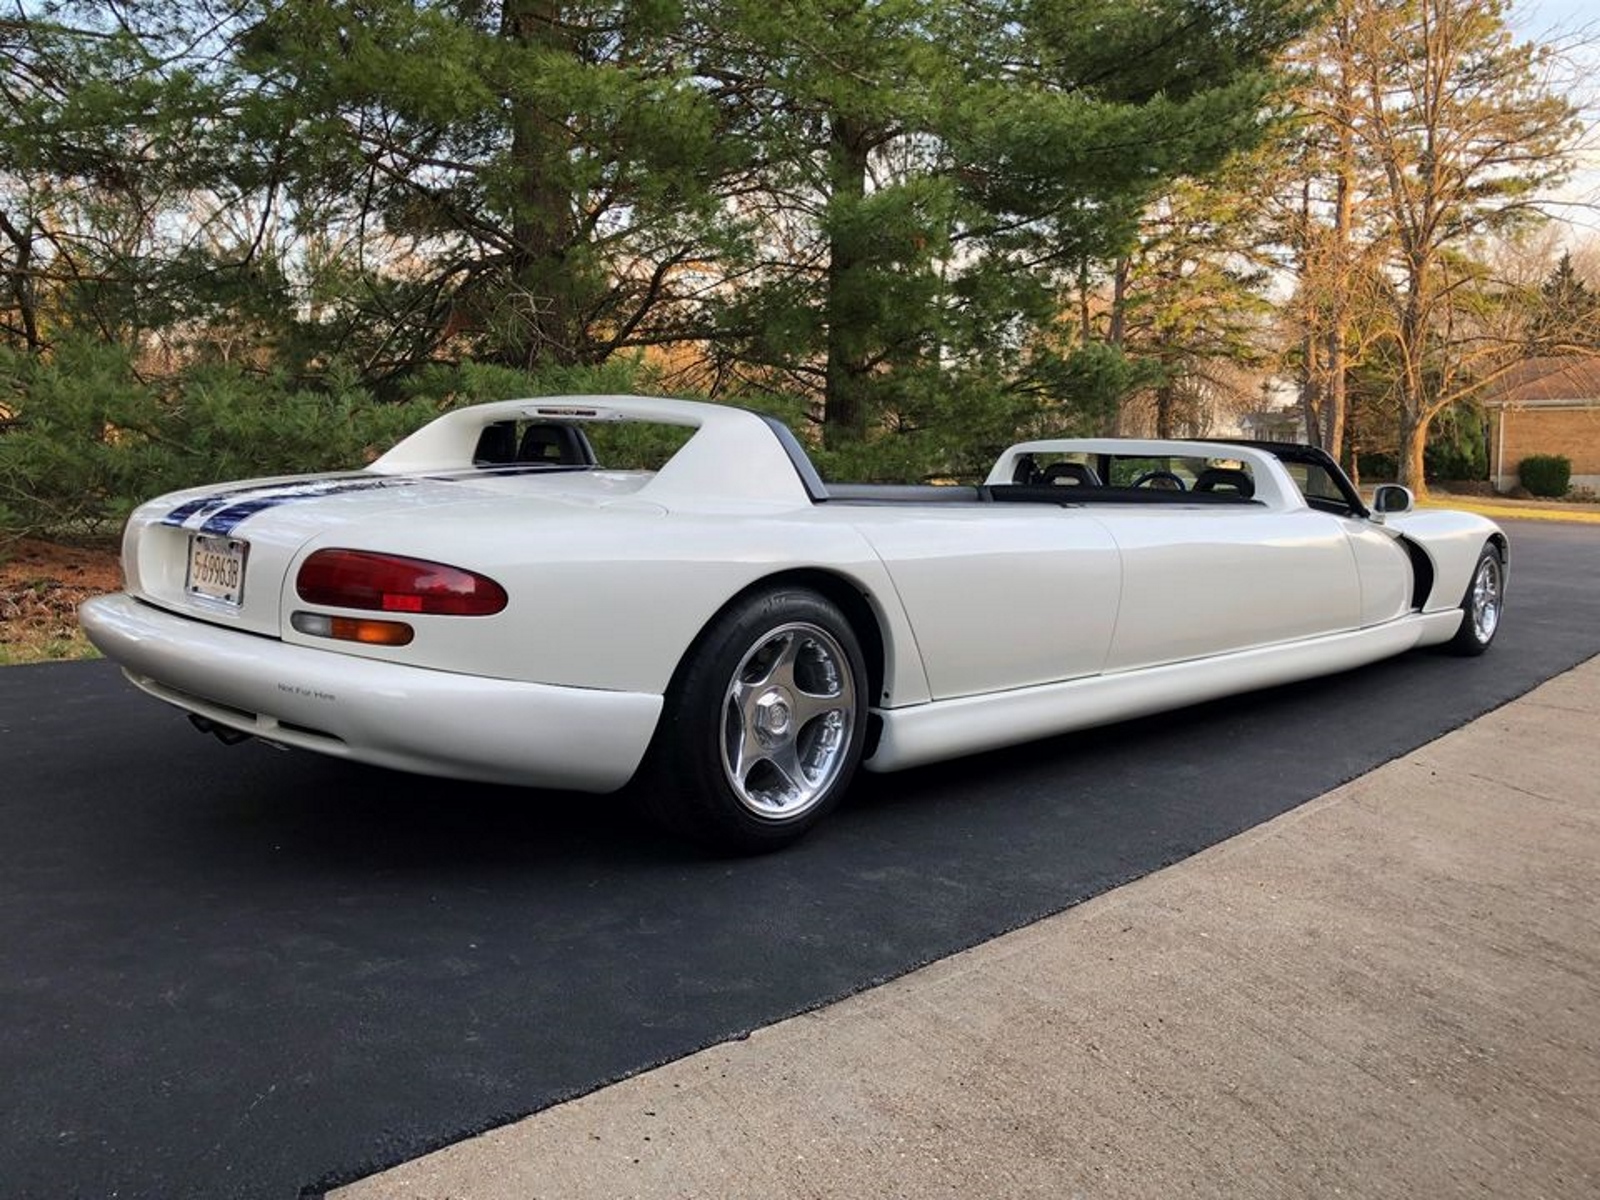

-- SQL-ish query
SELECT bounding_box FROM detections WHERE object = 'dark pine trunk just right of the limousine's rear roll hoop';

[822,114,872,450]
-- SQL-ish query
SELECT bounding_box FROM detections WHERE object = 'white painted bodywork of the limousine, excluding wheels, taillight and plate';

[82,397,1502,803]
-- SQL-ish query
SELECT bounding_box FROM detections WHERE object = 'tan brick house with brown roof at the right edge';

[1483,357,1600,491]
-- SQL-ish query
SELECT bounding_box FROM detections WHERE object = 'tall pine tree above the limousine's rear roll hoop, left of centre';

[232,0,725,366]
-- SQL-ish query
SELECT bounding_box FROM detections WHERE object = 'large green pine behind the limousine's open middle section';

[712,0,1307,443]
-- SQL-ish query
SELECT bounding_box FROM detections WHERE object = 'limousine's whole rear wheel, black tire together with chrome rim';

[635,587,870,854]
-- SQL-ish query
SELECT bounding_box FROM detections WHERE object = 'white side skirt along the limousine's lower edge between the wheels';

[862,610,1461,771]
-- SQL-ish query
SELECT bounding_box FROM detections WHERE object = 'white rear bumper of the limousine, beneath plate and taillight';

[78,595,662,792]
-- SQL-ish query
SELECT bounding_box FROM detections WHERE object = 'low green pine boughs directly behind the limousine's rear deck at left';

[0,338,653,538]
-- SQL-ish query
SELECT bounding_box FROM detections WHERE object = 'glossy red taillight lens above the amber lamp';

[294,550,506,616]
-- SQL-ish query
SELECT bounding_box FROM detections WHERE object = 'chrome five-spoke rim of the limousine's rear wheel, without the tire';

[722,621,856,819]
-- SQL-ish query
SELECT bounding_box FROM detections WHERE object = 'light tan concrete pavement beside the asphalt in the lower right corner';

[330,659,1600,1200]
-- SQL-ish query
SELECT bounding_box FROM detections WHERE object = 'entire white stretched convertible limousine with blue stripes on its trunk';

[82,397,1507,851]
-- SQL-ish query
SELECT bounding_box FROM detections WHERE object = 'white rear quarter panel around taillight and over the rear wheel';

[283,504,926,702]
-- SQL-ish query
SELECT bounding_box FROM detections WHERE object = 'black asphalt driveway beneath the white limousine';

[0,525,1600,1197]
